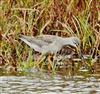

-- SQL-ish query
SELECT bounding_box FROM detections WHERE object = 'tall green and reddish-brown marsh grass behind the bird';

[0,0,100,71]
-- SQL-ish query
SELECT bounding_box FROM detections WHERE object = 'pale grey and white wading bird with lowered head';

[20,35,80,69]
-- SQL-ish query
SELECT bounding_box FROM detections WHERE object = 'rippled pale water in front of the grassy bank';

[0,73,100,94]
